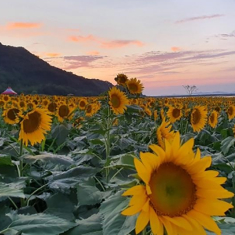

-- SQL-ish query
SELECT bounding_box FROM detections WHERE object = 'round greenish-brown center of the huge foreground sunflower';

[149,163,196,217]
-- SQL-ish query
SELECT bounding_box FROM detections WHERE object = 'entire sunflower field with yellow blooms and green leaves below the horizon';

[0,74,235,235]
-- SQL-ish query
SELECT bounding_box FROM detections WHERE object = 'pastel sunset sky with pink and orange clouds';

[0,0,235,96]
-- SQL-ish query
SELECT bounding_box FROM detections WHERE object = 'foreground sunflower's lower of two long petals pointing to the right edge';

[194,198,233,216]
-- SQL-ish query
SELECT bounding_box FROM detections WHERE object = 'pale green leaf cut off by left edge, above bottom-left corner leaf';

[0,181,25,200]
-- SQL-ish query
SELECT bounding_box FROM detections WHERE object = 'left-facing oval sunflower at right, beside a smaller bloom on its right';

[191,106,207,132]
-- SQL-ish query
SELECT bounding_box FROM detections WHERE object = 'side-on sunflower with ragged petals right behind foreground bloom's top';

[156,117,175,149]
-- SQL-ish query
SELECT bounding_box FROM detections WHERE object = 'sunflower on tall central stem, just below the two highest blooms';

[108,87,129,114]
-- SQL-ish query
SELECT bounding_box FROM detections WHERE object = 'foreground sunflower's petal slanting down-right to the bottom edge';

[187,210,221,235]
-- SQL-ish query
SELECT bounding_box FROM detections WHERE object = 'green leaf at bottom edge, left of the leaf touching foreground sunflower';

[64,214,103,235]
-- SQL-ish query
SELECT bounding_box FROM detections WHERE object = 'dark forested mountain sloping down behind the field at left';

[0,43,113,96]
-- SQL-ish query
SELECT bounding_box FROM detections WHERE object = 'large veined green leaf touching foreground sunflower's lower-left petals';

[100,192,137,235]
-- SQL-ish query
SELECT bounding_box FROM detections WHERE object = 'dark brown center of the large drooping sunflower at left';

[23,111,41,133]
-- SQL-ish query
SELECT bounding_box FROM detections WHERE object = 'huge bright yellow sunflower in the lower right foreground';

[122,132,233,235]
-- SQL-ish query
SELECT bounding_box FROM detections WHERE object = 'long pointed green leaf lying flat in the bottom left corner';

[0,213,75,235]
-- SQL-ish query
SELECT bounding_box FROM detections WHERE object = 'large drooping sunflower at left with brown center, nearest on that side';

[19,108,52,146]
